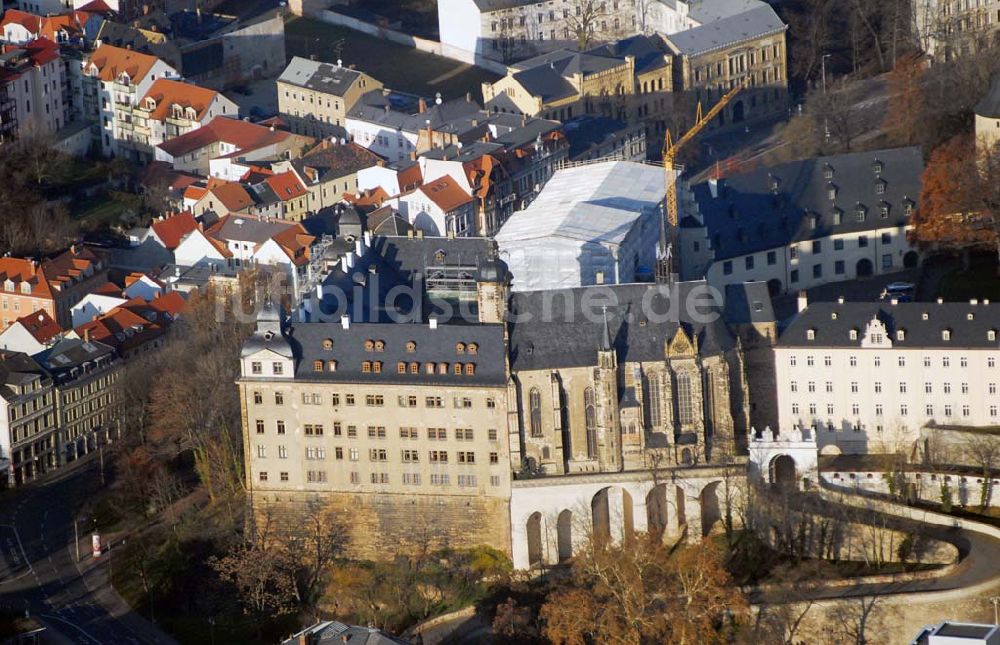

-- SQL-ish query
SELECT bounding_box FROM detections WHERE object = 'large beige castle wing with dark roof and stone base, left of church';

[239,302,511,559]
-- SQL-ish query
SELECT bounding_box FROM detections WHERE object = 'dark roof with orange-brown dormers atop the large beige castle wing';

[278,322,507,386]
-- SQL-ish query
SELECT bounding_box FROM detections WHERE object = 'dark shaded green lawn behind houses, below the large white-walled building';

[285,17,499,102]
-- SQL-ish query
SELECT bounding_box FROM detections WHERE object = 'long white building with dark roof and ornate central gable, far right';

[774,299,1000,455]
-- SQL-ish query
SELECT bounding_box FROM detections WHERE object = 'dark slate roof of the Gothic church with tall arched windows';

[509,281,735,370]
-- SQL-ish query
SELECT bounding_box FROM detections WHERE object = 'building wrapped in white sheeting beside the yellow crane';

[496,161,666,291]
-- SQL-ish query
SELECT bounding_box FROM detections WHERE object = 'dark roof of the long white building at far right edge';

[778,302,1000,349]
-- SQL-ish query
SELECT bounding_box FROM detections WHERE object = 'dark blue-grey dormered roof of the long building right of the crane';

[685,147,924,260]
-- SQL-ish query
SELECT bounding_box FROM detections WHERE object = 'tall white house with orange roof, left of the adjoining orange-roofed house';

[83,44,178,161]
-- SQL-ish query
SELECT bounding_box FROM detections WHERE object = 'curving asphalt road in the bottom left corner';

[0,459,174,645]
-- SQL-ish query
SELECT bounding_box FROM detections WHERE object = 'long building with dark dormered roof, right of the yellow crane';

[679,148,923,294]
